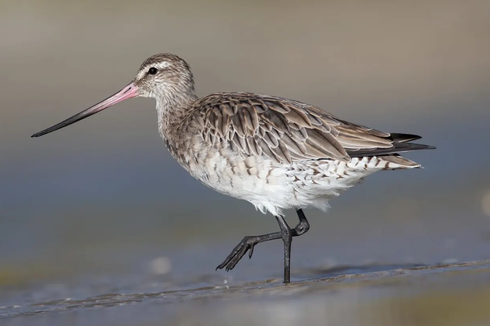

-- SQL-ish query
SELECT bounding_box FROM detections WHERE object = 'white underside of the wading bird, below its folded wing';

[187,146,385,215]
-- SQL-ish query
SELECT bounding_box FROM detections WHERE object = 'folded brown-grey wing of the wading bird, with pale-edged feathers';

[189,93,425,163]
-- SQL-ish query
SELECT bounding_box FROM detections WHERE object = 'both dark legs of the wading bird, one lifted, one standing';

[216,209,310,283]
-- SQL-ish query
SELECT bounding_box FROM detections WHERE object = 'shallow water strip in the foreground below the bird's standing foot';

[0,261,490,326]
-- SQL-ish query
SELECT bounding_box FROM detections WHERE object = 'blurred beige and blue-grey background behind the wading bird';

[0,0,490,325]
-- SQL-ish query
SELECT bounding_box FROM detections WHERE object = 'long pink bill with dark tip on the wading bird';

[31,82,139,137]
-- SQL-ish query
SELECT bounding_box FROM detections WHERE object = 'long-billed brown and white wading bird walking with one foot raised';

[31,53,435,284]
